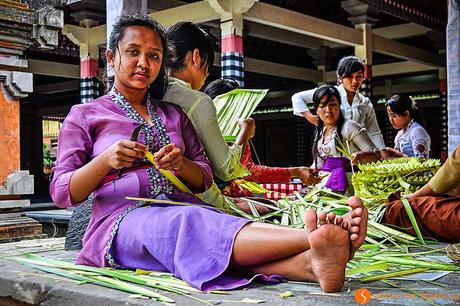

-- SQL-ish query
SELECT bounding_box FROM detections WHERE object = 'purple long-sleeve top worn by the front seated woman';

[50,95,213,266]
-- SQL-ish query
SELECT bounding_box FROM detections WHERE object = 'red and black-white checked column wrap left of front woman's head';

[80,58,99,103]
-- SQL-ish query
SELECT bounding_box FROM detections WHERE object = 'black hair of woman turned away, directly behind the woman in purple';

[166,22,214,71]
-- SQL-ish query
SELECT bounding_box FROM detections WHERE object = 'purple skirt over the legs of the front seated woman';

[110,202,283,291]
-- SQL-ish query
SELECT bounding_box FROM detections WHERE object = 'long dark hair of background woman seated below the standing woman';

[312,85,345,168]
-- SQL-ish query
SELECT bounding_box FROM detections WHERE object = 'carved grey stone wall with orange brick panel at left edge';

[0,0,64,204]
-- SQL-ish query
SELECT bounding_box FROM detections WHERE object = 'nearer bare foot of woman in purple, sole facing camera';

[308,224,350,292]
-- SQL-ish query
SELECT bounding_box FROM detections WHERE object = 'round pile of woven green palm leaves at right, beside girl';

[352,157,441,199]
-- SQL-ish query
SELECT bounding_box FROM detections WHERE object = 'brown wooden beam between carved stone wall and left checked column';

[25,59,80,79]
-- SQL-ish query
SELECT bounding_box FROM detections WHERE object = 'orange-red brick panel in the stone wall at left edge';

[0,84,21,185]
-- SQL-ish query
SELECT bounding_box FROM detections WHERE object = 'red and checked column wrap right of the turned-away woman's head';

[221,34,244,87]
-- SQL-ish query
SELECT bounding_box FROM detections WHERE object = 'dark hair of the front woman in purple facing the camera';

[106,15,168,99]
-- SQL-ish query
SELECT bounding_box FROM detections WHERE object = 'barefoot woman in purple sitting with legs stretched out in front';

[51,16,367,292]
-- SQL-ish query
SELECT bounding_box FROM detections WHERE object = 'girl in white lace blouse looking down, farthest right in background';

[385,94,431,158]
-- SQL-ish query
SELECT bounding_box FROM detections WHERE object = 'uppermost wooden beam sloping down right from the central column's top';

[243,2,363,47]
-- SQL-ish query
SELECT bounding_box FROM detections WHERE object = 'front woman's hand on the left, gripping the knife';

[103,140,147,169]
